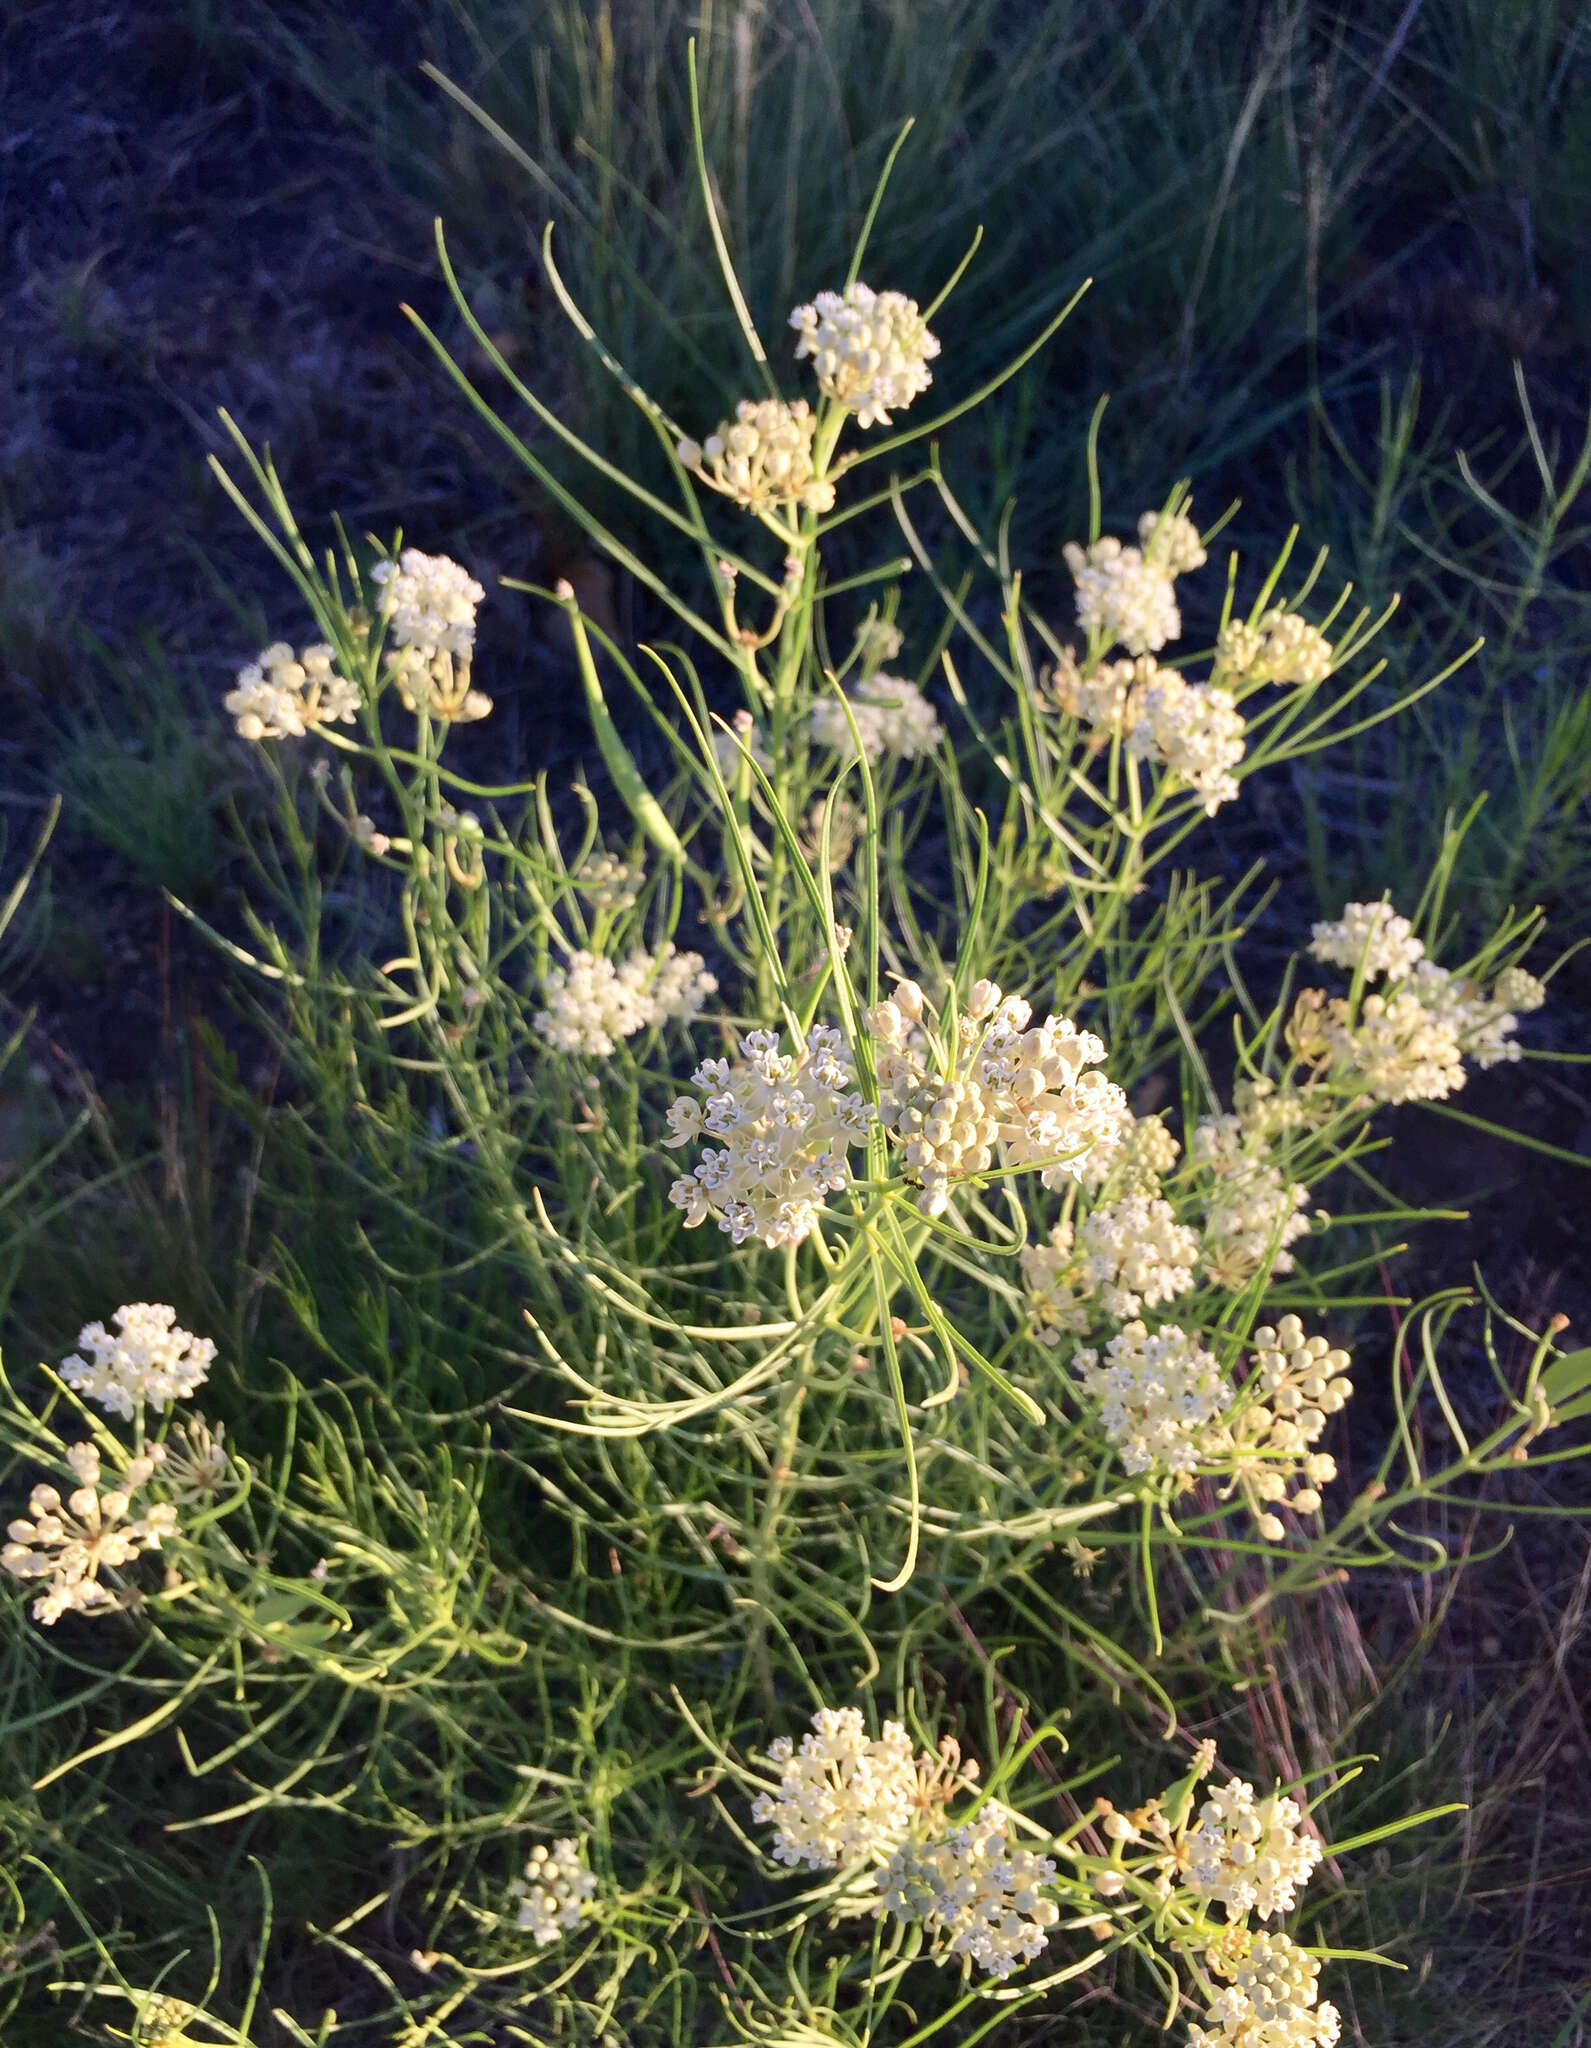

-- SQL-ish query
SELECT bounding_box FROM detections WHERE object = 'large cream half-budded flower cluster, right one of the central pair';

[866,981,1128,1217]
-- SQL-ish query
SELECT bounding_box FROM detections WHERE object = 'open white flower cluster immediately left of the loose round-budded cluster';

[1075,1323,1233,1487]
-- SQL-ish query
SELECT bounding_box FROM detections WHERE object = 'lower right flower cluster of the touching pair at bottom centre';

[880,1800,1061,1978]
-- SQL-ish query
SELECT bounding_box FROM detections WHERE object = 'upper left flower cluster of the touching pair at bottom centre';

[751,1706,919,1870]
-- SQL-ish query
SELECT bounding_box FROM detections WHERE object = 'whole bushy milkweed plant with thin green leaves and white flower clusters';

[2,79,1573,2048]
